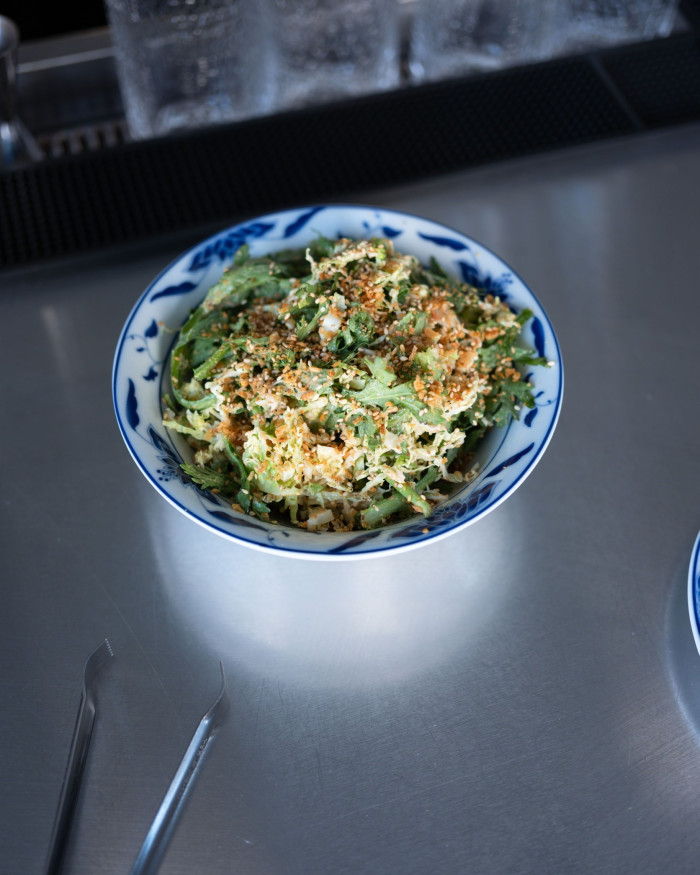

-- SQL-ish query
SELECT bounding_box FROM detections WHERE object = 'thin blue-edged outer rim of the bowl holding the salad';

[111,202,568,560]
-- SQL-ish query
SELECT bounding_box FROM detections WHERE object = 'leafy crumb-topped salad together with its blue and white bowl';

[113,206,563,558]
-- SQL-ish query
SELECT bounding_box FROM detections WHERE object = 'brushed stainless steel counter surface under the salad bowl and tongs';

[0,126,700,875]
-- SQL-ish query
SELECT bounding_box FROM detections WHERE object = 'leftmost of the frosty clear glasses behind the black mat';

[106,0,272,139]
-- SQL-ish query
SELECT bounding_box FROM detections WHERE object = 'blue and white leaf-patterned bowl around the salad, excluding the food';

[112,205,563,559]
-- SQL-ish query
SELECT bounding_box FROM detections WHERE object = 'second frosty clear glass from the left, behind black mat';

[266,0,400,109]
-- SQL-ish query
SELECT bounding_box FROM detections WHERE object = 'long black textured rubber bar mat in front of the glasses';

[0,33,700,267]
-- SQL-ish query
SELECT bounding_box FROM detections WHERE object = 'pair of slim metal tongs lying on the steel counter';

[46,638,229,875]
